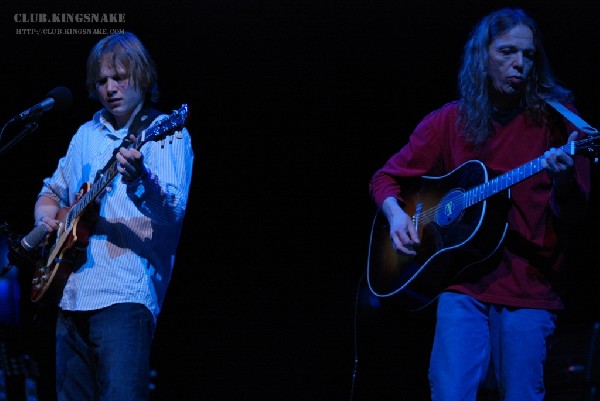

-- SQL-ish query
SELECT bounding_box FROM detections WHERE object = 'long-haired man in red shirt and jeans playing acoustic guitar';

[370,8,590,401]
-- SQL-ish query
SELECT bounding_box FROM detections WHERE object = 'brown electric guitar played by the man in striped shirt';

[31,104,188,303]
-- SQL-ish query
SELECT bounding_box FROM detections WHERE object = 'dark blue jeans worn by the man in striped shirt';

[56,303,155,401]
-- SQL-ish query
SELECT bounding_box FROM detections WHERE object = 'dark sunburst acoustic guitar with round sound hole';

[367,136,600,311]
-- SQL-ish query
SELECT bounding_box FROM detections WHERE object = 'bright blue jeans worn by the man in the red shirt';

[429,292,556,401]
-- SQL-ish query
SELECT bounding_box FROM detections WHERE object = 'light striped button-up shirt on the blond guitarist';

[39,104,194,319]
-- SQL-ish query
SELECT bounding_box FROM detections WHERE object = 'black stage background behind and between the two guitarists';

[0,0,600,401]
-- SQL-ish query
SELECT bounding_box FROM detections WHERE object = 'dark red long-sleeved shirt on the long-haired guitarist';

[370,101,590,309]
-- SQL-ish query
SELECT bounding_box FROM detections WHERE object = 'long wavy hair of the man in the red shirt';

[458,8,573,144]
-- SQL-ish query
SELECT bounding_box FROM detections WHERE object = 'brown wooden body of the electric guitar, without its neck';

[31,183,95,303]
